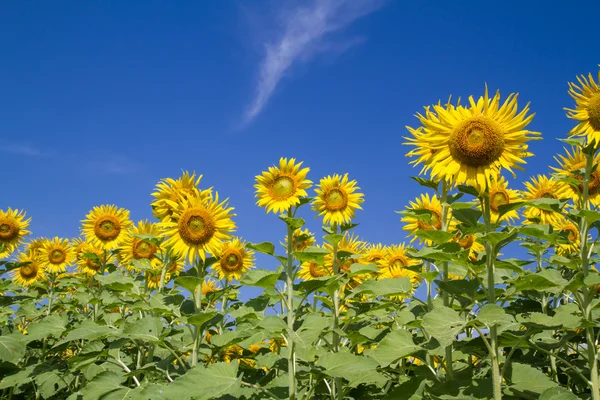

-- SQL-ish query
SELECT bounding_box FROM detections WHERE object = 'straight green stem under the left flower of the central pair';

[286,207,296,400]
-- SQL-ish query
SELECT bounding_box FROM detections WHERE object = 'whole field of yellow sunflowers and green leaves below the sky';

[0,67,600,400]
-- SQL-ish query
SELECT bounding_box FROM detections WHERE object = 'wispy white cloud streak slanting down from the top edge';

[244,0,385,124]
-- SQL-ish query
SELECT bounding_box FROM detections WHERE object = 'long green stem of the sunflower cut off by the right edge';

[579,149,600,400]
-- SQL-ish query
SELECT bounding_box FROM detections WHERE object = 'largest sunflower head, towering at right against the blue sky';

[406,87,539,193]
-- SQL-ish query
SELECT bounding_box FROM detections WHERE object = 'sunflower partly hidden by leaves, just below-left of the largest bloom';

[402,193,456,246]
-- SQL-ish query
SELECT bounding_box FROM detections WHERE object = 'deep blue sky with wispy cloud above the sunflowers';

[0,0,600,278]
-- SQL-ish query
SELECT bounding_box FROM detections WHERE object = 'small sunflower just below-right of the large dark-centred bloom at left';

[212,238,254,281]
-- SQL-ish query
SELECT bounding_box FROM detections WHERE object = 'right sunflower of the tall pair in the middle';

[313,174,364,225]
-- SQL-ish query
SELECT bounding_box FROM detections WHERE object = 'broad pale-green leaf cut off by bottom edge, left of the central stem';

[165,362,241,400]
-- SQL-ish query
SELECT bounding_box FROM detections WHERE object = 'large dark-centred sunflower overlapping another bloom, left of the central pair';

[159,193,236,263]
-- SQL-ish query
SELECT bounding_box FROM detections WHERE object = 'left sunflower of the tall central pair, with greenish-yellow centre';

[254,158,312,213]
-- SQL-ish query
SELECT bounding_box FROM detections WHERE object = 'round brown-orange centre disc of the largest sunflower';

[448,116,504,167]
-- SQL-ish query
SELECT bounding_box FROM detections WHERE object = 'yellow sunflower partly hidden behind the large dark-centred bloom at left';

[151,171,212,221]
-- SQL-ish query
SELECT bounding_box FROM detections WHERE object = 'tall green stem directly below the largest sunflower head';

[482,190,502,400]
